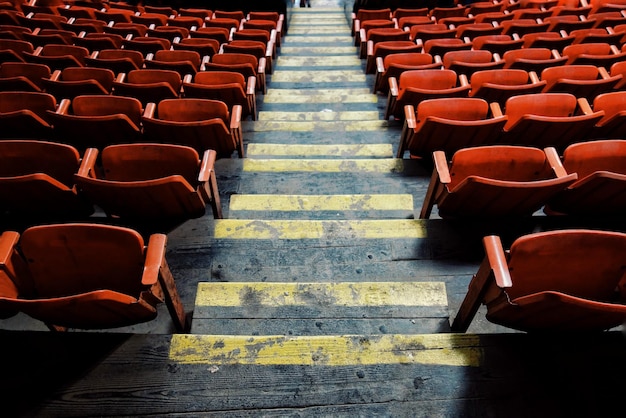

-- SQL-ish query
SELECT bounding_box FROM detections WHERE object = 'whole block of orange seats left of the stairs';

[0,0,283,332]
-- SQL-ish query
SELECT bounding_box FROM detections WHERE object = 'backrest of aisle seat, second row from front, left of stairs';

[102,144,200,185]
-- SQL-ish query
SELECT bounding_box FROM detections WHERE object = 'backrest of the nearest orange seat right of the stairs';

[506,230,626,301]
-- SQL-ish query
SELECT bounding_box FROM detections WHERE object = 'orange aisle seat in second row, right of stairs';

[420,145,577,219]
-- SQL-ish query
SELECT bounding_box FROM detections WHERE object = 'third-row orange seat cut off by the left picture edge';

[0,91,57,139]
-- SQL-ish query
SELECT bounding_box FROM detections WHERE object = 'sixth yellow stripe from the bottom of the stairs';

[246,144,393,158]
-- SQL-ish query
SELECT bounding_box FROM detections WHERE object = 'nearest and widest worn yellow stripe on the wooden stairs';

[169,334,482,367]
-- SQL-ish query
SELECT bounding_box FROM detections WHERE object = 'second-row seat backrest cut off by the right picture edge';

[563,139,626,179]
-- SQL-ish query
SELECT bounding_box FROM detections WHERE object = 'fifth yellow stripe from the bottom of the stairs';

[243,158,404,173]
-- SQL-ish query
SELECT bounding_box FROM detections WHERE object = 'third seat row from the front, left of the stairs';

[0,92,243,157]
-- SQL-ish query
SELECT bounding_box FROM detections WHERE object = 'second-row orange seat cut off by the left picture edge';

[0,139,94,222]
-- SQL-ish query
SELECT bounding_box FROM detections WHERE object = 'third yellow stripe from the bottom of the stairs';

[213,219,426,239]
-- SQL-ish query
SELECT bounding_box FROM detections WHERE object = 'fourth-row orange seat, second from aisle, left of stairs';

[113,68,182,107]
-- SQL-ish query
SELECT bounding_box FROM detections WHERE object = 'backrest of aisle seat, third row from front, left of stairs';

[157,99,230,126]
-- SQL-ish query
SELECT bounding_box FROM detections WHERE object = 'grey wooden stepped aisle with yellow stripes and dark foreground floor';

[0,0,626,417]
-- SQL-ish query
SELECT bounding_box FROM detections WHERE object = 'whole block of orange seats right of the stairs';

[353,0,626,332]
